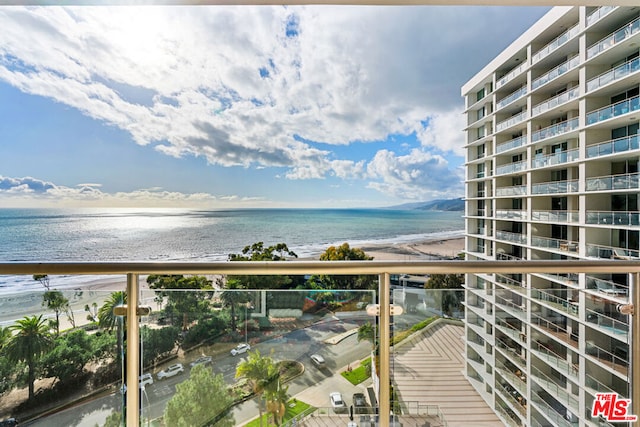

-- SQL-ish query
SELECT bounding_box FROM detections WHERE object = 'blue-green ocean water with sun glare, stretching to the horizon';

[0,208,464,292]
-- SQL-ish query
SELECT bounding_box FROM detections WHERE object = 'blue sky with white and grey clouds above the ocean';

[0,6,548,209]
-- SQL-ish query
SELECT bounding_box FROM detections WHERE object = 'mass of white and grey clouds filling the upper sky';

[0,7,542,202]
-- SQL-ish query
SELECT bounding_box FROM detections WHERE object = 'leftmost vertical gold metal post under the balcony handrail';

[126,273,142,426]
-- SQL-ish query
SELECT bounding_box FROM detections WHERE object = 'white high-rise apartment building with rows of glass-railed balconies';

[462,6,640,427]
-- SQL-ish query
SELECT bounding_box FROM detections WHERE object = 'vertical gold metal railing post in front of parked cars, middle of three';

[378,273,391,427]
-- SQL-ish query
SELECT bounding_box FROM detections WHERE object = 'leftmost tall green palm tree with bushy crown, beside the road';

[5,315,53,399]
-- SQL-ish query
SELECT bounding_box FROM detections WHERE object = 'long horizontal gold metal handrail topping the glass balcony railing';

[0,260,640,275]
